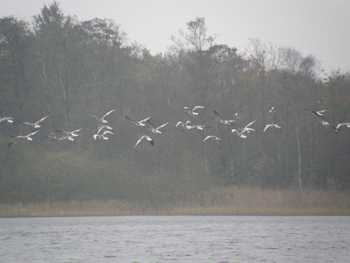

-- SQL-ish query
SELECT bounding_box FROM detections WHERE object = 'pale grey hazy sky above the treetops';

[0,0,350,73]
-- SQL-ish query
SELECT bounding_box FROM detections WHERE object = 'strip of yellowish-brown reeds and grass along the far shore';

[0,187,350,217]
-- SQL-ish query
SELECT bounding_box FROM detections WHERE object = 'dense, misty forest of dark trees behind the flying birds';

[0,2,350,205]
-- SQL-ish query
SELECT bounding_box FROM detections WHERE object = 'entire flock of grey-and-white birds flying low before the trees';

[0,100,350,148]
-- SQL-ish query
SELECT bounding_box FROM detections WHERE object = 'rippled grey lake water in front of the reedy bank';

[0,216,350,263]
